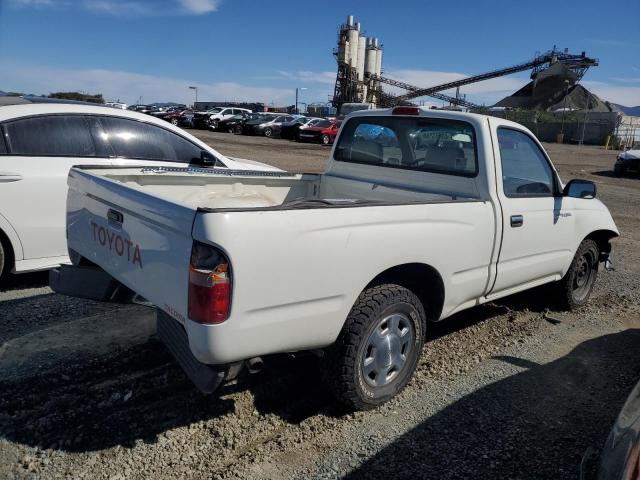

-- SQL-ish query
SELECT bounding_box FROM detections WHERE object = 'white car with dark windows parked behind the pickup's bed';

[0,103,273,275]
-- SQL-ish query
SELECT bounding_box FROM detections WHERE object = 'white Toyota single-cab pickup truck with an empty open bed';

[51,107,618,409]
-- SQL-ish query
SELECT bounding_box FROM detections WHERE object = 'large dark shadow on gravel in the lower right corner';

[346,329,640,479]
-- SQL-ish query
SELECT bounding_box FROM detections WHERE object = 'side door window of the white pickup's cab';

[498,128,554,197]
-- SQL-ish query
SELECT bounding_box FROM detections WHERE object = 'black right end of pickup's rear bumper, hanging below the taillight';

[158,310,227,393]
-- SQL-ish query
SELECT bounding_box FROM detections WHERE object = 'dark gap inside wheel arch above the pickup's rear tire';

[365,263,445,321]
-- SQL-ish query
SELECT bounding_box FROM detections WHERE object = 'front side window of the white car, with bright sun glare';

[99,117,201,163]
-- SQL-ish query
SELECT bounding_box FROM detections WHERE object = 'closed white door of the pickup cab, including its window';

[488,127,575,297]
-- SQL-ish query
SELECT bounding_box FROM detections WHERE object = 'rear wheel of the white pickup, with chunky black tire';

[322,284,426,410]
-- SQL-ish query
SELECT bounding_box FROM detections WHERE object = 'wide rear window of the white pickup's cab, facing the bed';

[335,116,478,176]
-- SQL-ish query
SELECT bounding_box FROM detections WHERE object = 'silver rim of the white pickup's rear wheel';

[361,313,415,387]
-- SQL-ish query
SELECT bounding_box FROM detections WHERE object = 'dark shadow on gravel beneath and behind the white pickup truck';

[0,286,584,452]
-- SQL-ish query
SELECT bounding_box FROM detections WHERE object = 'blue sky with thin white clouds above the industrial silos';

[0,0,640,105]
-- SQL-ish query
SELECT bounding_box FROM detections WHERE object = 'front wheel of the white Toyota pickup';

[555,239,600,310]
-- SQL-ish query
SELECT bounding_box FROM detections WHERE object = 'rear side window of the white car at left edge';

[5,115,96,157]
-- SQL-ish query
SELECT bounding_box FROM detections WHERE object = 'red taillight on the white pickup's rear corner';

[189,242,231,324]
